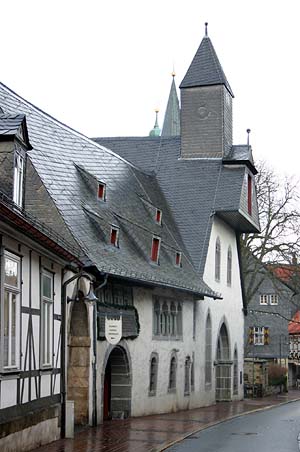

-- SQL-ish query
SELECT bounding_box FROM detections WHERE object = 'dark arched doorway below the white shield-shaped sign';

[103,345,131,420]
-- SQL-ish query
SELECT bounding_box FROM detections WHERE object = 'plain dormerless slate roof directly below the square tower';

[95,137,258,275]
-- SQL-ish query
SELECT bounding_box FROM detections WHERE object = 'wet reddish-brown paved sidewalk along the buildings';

[35,390,300,452]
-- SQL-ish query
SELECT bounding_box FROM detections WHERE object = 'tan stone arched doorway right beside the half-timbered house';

[67,300,91,425]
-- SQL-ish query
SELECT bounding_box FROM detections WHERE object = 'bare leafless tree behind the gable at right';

[241,162,300,302]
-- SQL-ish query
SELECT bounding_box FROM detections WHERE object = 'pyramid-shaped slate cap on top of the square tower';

[180,36,234,97]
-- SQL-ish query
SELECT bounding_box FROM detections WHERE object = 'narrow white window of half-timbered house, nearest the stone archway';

[41,269,54,367]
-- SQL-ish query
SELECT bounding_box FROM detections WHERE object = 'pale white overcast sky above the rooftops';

[0,0,300,174]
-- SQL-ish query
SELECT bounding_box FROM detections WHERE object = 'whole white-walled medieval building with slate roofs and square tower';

[0,23,259,444]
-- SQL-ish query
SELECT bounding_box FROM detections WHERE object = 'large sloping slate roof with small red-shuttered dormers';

[0,84,217,297]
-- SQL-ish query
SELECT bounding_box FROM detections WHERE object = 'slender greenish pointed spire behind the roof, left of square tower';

[161,72,180,137]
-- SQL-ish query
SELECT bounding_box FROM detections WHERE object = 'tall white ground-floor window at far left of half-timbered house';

[1,251,21,370]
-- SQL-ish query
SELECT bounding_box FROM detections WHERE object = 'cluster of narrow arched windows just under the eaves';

[153,297,182,339]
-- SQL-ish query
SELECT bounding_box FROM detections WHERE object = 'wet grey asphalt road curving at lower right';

[166,401,300,452]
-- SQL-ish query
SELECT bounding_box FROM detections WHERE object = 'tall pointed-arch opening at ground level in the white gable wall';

[216,323,232,402]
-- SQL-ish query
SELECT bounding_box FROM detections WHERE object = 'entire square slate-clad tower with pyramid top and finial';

[180,23,234,158]
